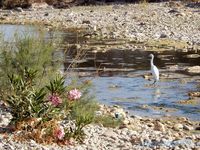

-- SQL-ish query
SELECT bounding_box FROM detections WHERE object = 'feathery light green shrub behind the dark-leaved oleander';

[0,34,60,91]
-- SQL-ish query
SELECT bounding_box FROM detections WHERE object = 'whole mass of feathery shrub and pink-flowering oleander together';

[0,31,98,144]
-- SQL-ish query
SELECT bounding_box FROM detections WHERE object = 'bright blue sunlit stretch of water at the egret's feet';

[88,74,200,119]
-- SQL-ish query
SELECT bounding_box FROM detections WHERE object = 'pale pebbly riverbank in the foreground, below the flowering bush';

[0,105,200,150]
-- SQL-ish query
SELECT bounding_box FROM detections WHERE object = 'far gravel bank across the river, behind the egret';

[0,2,200,45]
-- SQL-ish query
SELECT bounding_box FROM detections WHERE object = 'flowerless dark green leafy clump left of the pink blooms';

[4,68,47,123]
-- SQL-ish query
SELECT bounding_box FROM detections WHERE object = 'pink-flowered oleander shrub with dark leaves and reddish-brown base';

[4,65,98,142]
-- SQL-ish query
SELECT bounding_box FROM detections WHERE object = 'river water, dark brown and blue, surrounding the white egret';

[0,25,200,120]
